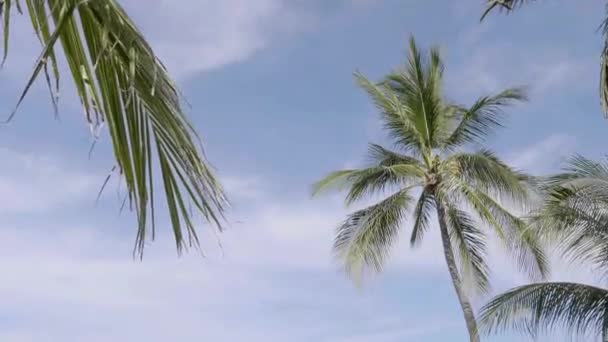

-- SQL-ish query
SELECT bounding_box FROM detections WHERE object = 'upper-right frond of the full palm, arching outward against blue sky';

[444,88,528,148]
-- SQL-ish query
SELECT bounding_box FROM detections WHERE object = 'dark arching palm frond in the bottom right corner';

[480,283,608,340]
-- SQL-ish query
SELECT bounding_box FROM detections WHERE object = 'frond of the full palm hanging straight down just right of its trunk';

[447,205,490,294]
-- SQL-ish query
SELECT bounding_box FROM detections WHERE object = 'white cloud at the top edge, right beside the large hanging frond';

[124,0,314,77]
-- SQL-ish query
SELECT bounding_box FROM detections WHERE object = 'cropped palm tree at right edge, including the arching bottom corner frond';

[481,156,608,341]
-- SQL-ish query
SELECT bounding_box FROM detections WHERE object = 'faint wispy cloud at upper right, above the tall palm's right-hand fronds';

[446,39,597,103]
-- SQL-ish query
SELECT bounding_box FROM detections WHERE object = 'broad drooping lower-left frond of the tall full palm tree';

[334,188,412,279]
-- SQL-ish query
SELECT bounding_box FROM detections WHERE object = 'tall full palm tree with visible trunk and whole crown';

[313,38,547,341]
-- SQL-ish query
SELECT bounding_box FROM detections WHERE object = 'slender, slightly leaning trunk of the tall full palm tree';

[437,201,479,342]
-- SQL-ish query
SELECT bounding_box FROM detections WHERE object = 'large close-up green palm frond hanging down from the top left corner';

[0,0,226,255]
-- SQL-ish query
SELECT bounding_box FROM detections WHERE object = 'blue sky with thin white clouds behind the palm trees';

[0,0,608,342]
